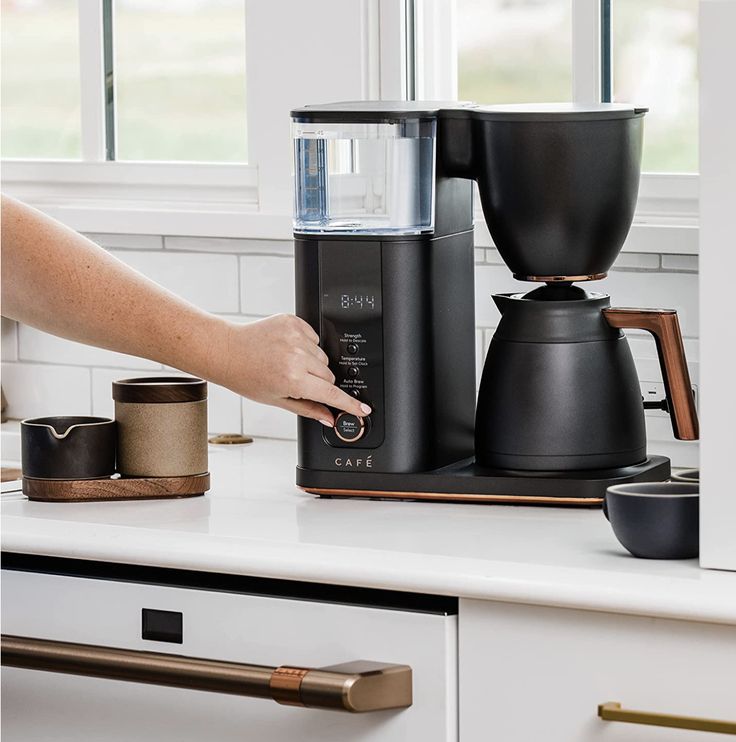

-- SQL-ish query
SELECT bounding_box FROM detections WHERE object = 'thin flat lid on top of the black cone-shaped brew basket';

[440,103,649,121]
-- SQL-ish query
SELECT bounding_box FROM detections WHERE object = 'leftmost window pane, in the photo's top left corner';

[0,0,82,159]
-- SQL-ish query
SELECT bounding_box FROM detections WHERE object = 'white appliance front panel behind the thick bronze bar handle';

[2,570,457,742]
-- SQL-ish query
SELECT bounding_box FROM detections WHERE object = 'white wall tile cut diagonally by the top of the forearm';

[115,250,239,313]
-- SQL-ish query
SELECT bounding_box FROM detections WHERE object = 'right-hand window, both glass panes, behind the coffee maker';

[456,0,698,173]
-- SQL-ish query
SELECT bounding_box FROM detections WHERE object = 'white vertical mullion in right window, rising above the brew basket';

[572,0,602,103]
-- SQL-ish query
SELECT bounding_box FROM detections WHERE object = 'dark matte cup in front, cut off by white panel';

[603,482,700,559]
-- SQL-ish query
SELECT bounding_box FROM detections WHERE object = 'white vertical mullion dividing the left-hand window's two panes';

[78,0,105,162]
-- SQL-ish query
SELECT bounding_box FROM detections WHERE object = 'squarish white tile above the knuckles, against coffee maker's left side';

[240,255,294,315]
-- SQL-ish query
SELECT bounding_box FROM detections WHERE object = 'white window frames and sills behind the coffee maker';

[3,0,699,254]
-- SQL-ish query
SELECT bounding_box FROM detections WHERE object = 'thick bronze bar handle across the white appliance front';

[2,634,412,713]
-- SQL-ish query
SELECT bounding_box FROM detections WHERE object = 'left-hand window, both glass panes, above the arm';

[2,0,248,162]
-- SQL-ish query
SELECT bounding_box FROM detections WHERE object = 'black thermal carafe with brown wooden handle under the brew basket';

[475,285,698,472]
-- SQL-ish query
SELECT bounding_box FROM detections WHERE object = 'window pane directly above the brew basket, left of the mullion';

[457,0,572,103]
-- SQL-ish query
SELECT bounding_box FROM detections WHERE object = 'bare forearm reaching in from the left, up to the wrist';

[2,197,224,377]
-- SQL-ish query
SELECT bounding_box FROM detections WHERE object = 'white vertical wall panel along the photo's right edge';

[700,0,736,570]
